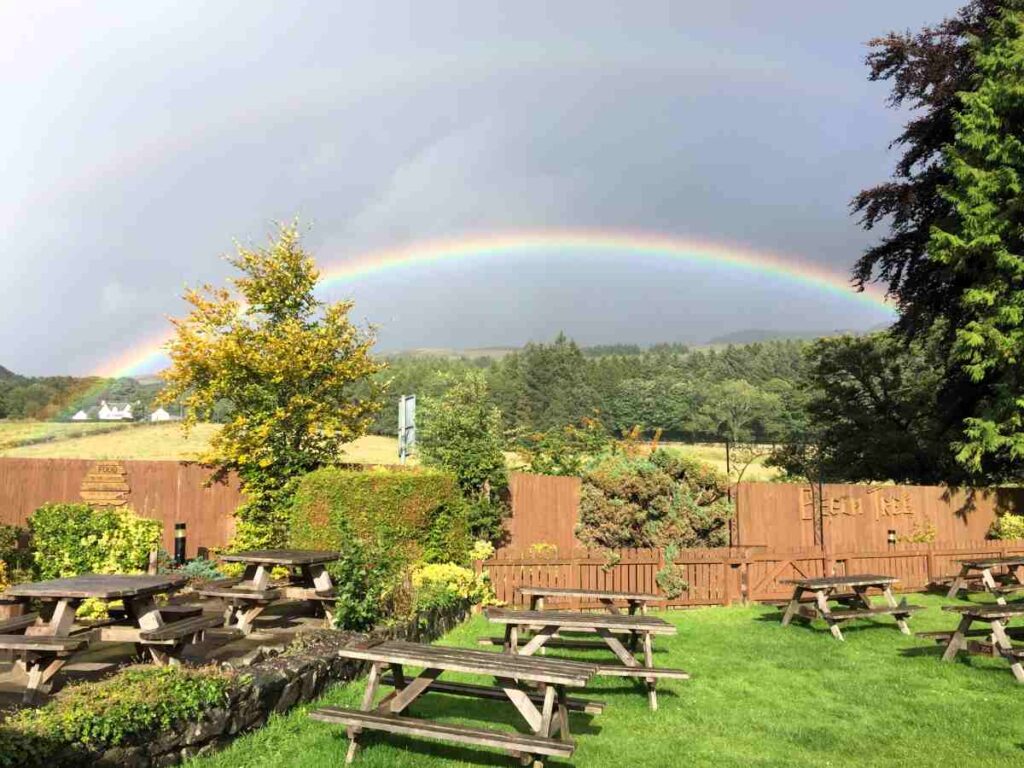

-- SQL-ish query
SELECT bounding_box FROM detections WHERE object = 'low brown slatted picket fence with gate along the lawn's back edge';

[479,541,1024,608]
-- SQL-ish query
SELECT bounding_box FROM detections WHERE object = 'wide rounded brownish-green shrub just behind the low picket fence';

[577,450,733,549]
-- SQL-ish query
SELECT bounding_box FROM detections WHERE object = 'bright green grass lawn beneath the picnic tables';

[188,596,1024,768]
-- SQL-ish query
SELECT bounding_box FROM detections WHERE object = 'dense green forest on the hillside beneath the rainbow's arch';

[375,336,807,441]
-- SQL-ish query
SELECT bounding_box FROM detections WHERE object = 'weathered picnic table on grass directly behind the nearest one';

[486,608,690,710]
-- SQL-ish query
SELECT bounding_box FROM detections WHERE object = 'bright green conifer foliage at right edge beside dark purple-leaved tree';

[928,0,1024,476]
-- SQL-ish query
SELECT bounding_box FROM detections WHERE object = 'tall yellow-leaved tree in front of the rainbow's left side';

[160,224,383,548]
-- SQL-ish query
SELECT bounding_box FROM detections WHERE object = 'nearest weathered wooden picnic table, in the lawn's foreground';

[310,640,601,766]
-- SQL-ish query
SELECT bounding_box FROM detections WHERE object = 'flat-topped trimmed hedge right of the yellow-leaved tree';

[290,468,472,563]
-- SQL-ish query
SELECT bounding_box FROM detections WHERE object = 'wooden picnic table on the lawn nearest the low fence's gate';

[782,573,923,640]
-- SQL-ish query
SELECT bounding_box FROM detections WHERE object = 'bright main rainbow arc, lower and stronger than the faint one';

[97,229,894,378]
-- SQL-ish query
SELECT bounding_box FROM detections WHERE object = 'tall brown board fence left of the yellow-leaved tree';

[0,459,243,557]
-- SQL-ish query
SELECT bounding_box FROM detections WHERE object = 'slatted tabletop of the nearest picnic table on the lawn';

[338,640,597,686]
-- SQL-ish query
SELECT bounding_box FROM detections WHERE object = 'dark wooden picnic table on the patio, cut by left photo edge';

[0,573,219,703]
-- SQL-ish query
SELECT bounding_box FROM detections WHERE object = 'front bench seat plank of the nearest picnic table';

[309,707,575,758]
